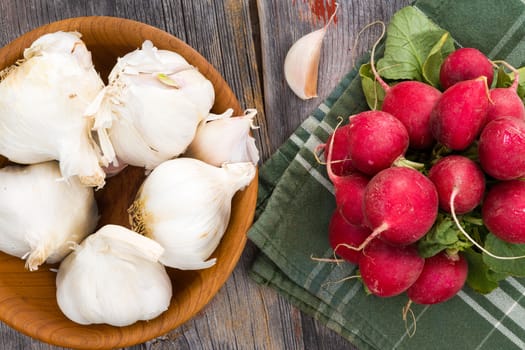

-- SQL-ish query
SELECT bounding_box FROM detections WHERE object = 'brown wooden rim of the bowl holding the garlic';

[0,16,258,349]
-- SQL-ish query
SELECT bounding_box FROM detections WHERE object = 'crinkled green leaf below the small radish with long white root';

[418,214,472,258]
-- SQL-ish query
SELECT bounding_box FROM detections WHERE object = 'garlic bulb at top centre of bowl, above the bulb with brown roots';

[86,41,215,169]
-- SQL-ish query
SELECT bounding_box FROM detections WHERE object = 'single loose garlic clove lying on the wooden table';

[284,3,337,100]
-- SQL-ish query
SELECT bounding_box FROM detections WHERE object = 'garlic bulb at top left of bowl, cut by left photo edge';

[0,32,104,187]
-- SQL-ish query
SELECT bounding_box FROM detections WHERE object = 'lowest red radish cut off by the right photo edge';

[481,180,525,244]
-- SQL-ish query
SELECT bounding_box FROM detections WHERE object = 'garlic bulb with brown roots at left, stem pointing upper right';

[128,158,255,270]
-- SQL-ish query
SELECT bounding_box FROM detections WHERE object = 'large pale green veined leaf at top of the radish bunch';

[377,6,448,81]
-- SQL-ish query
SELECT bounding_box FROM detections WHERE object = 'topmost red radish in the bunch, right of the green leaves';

[439,47,494,90]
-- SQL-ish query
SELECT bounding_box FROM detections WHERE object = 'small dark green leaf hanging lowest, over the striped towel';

[464,248,498,294]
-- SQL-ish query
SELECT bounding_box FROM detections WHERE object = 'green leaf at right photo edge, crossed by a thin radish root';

[483,233,525,277]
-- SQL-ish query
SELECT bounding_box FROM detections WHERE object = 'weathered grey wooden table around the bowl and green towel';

[0,0,410,350]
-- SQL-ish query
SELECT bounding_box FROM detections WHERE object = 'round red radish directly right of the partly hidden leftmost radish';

[348,111,409,175]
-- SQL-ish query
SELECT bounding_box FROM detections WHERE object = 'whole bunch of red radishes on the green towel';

[324,48,525,305]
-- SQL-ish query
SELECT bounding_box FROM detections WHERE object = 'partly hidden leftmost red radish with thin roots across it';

[320,124,354,176]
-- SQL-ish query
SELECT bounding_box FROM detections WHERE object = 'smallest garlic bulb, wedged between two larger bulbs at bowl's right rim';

[185,109,259,166]
